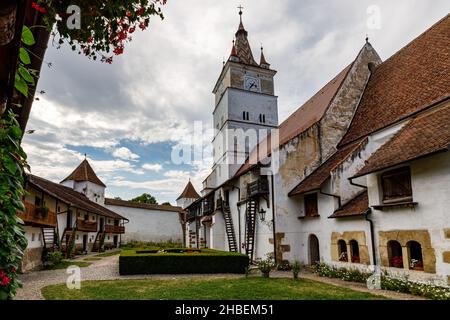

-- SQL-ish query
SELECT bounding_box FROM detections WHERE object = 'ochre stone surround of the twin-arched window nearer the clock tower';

[331,231,370,265]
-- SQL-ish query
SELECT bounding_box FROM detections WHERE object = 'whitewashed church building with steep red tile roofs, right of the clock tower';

[183,15,450,283]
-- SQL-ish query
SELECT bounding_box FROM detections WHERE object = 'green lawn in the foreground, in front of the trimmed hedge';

[42,277,384,300]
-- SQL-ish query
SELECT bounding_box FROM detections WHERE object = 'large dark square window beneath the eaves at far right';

[381,167,412,203]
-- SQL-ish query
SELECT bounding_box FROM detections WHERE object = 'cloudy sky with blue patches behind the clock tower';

[24,0,450,203]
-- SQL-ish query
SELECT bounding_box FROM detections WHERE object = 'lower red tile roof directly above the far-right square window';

[355,105,450,177]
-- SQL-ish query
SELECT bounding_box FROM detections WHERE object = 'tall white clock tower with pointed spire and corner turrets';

[207,8,278,191]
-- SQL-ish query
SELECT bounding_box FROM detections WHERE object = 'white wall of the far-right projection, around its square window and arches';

[367,152,450,280]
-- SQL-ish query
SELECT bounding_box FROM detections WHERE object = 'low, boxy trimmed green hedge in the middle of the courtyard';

[119,249,249,275]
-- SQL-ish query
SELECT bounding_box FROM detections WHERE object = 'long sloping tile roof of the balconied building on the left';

[27,174,128,220]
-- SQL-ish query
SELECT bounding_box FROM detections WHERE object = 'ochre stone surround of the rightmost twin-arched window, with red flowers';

[379,230,436,273]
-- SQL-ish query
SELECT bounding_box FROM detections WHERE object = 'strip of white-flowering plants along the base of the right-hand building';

[313,263,450,300]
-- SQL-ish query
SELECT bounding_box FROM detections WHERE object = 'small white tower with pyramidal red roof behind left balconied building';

[61,159,106,206]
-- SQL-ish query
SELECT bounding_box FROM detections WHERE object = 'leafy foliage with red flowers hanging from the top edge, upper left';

[33,0,167,63]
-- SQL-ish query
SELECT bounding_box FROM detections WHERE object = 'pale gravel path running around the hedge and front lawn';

[15,255,424,300]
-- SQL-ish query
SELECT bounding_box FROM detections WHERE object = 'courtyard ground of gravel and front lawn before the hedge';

[15,254,423,300]
